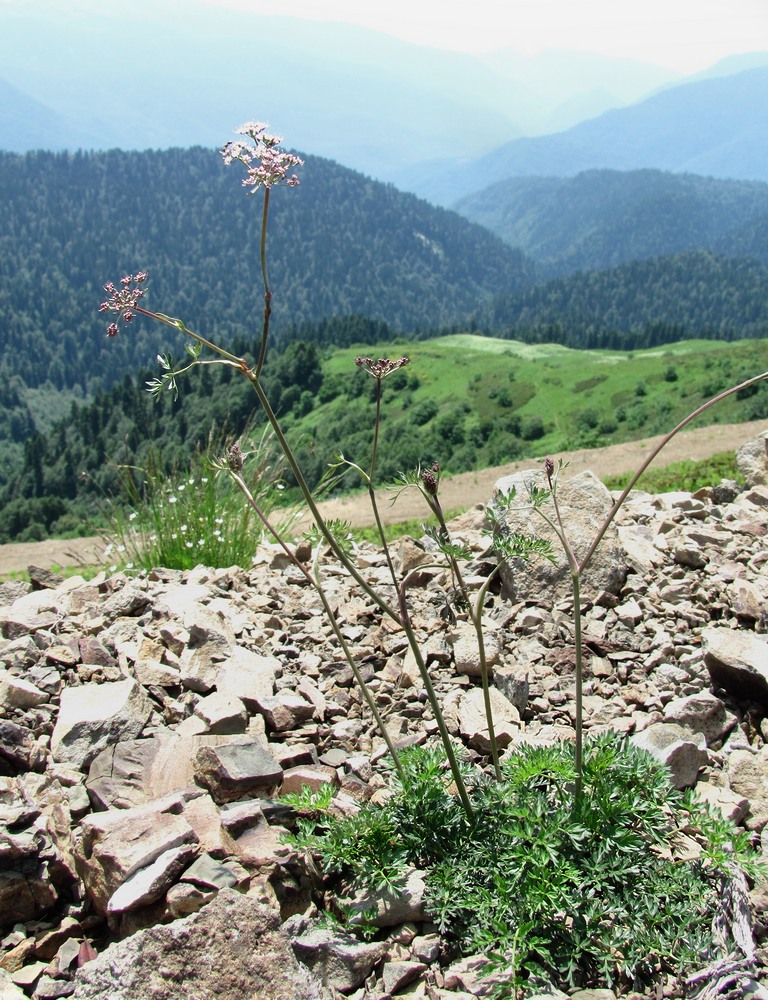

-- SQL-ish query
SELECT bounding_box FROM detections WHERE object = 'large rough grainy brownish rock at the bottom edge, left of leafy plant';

[73,889,322,1000]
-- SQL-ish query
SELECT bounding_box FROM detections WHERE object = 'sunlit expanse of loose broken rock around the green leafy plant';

[0,432,768,1000]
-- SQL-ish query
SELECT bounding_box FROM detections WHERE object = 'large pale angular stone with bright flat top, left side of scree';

[51,677,152,769]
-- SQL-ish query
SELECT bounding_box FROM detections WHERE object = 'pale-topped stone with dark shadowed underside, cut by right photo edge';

[701,626,768,702]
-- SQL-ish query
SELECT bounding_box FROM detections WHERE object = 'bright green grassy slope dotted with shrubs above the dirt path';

[280,334,768,486]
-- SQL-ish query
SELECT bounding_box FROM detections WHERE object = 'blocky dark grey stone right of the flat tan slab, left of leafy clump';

[195,737,283,802]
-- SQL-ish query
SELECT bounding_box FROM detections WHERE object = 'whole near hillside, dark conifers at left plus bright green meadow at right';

[0,334,768,541]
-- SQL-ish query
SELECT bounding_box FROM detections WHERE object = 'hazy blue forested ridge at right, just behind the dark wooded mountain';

[455,170,768,275]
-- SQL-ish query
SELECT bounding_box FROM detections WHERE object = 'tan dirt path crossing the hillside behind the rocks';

[0,420,768,578]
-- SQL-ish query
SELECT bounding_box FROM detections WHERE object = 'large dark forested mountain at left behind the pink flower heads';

[0,148,532,396]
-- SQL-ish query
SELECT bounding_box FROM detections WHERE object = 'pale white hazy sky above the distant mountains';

[206,0,768,73]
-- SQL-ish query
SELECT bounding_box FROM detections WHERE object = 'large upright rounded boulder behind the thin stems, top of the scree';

[488,469,628,601]
